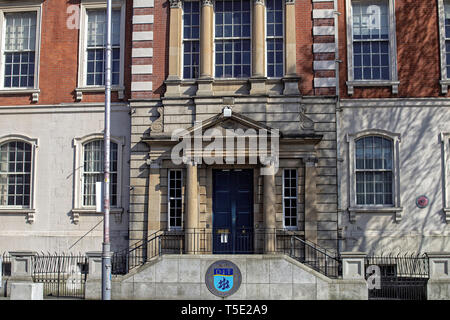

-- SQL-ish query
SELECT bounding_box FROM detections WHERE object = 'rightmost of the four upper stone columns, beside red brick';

[283,0,300,95]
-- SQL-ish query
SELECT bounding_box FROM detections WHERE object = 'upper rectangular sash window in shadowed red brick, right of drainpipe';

[352,0,391,80]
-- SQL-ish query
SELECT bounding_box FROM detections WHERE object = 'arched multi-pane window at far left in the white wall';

[0,140,33,208]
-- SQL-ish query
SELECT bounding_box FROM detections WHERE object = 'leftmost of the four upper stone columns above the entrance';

[166,0,183,96]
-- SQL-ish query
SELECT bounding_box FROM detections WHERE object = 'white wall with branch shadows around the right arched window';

[345,104,450,253]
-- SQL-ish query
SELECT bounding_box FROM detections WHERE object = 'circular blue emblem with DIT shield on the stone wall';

[205,260,242,298]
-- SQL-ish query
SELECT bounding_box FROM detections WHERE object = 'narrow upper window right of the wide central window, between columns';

[266,0,283,77]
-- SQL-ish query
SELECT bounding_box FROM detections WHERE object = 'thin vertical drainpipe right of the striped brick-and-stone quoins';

[334,0,342,256]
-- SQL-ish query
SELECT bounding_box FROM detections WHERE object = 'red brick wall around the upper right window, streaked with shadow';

[339,0,442,98]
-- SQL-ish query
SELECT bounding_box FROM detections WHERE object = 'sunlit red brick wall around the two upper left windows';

[0,0,132,105]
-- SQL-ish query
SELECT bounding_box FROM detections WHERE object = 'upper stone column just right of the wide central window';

[250,0,266,94]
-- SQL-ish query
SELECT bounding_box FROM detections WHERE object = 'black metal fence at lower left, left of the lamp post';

[32,253,88,298]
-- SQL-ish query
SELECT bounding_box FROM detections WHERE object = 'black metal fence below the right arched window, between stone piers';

[365,253,430,300]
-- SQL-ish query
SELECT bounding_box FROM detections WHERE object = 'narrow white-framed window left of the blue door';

[168,170,183,229]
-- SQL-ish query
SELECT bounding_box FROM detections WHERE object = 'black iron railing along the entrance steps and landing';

[112,228,340,278]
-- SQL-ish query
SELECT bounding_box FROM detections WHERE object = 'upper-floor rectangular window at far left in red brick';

[3,12,37,88]
